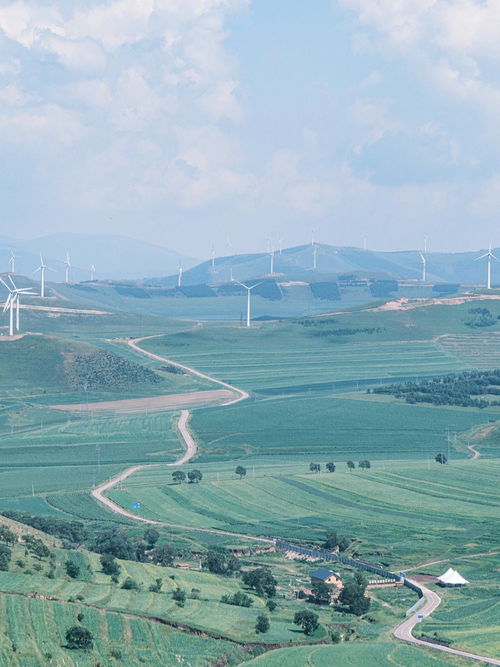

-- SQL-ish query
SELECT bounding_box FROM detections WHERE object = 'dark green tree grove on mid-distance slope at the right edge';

[374,369,500,408]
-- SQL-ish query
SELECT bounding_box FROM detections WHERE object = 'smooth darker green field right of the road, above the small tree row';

[188,394,499,462]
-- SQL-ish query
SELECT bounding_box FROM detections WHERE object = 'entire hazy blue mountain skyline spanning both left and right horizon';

[0,233,500,286]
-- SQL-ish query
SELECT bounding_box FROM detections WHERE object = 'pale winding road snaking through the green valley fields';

[92,334,500,666]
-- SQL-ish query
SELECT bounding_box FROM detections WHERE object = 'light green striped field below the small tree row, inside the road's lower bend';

[110,460,500,569]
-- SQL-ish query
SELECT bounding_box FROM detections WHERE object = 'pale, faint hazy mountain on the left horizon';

[0,233,198,282]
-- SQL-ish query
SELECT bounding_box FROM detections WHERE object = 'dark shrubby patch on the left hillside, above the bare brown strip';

[64,350,162,390]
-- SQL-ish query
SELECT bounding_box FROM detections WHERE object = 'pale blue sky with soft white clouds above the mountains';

[0,0,500,258]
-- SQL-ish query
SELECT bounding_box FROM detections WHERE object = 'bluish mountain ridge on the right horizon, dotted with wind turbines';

[147,244,500,286]
